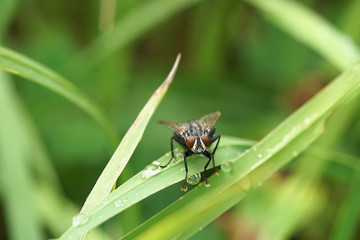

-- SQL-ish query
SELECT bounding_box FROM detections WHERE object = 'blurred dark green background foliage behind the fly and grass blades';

[0,0,360,239]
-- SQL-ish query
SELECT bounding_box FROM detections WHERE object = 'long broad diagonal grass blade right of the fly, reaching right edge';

[123,61,360,239]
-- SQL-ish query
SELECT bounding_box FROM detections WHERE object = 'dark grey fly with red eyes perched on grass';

[158,111,221,191]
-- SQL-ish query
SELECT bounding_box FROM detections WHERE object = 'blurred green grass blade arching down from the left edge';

[0,46,118,146]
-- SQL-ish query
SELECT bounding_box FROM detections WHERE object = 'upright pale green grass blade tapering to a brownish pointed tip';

[77,54,181,218]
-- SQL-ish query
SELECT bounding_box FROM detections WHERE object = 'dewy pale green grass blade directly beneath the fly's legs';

[60,136,254,239]
